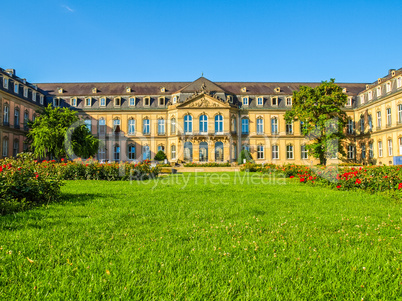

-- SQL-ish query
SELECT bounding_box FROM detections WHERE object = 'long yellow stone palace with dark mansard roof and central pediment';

[0,69,402,165]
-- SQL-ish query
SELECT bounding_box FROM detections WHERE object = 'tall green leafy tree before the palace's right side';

[285,79,347,165]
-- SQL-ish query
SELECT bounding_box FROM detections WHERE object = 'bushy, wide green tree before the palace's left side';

[27,104,99,160]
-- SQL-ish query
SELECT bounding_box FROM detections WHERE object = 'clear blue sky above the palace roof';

[0,0,402,82]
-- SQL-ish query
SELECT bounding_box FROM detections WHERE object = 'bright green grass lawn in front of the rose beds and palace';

[0,173,402,300]
